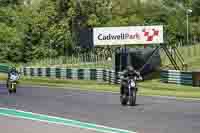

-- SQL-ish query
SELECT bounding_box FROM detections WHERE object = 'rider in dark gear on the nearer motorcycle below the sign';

[120,65,142,96]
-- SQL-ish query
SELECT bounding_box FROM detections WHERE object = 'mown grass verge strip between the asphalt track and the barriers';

[0,74,200,99]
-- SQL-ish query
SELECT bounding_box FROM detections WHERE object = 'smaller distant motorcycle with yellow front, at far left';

[8,73,19,94]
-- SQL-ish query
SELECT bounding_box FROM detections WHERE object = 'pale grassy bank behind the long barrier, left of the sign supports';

[27,54,112,69]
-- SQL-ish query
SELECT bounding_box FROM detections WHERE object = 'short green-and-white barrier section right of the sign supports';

[160,70,200,86]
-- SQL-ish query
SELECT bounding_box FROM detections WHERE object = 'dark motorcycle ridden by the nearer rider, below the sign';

[120,76,142,106]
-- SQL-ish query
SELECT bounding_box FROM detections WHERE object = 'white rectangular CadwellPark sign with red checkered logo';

[93,26,163,46]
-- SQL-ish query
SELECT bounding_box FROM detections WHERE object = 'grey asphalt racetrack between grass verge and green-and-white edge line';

[0,85,200,133]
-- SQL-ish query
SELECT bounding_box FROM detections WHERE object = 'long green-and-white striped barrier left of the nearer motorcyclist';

[20,67,121,84]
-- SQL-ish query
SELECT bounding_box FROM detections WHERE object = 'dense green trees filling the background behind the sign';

[0,0,200,63]
